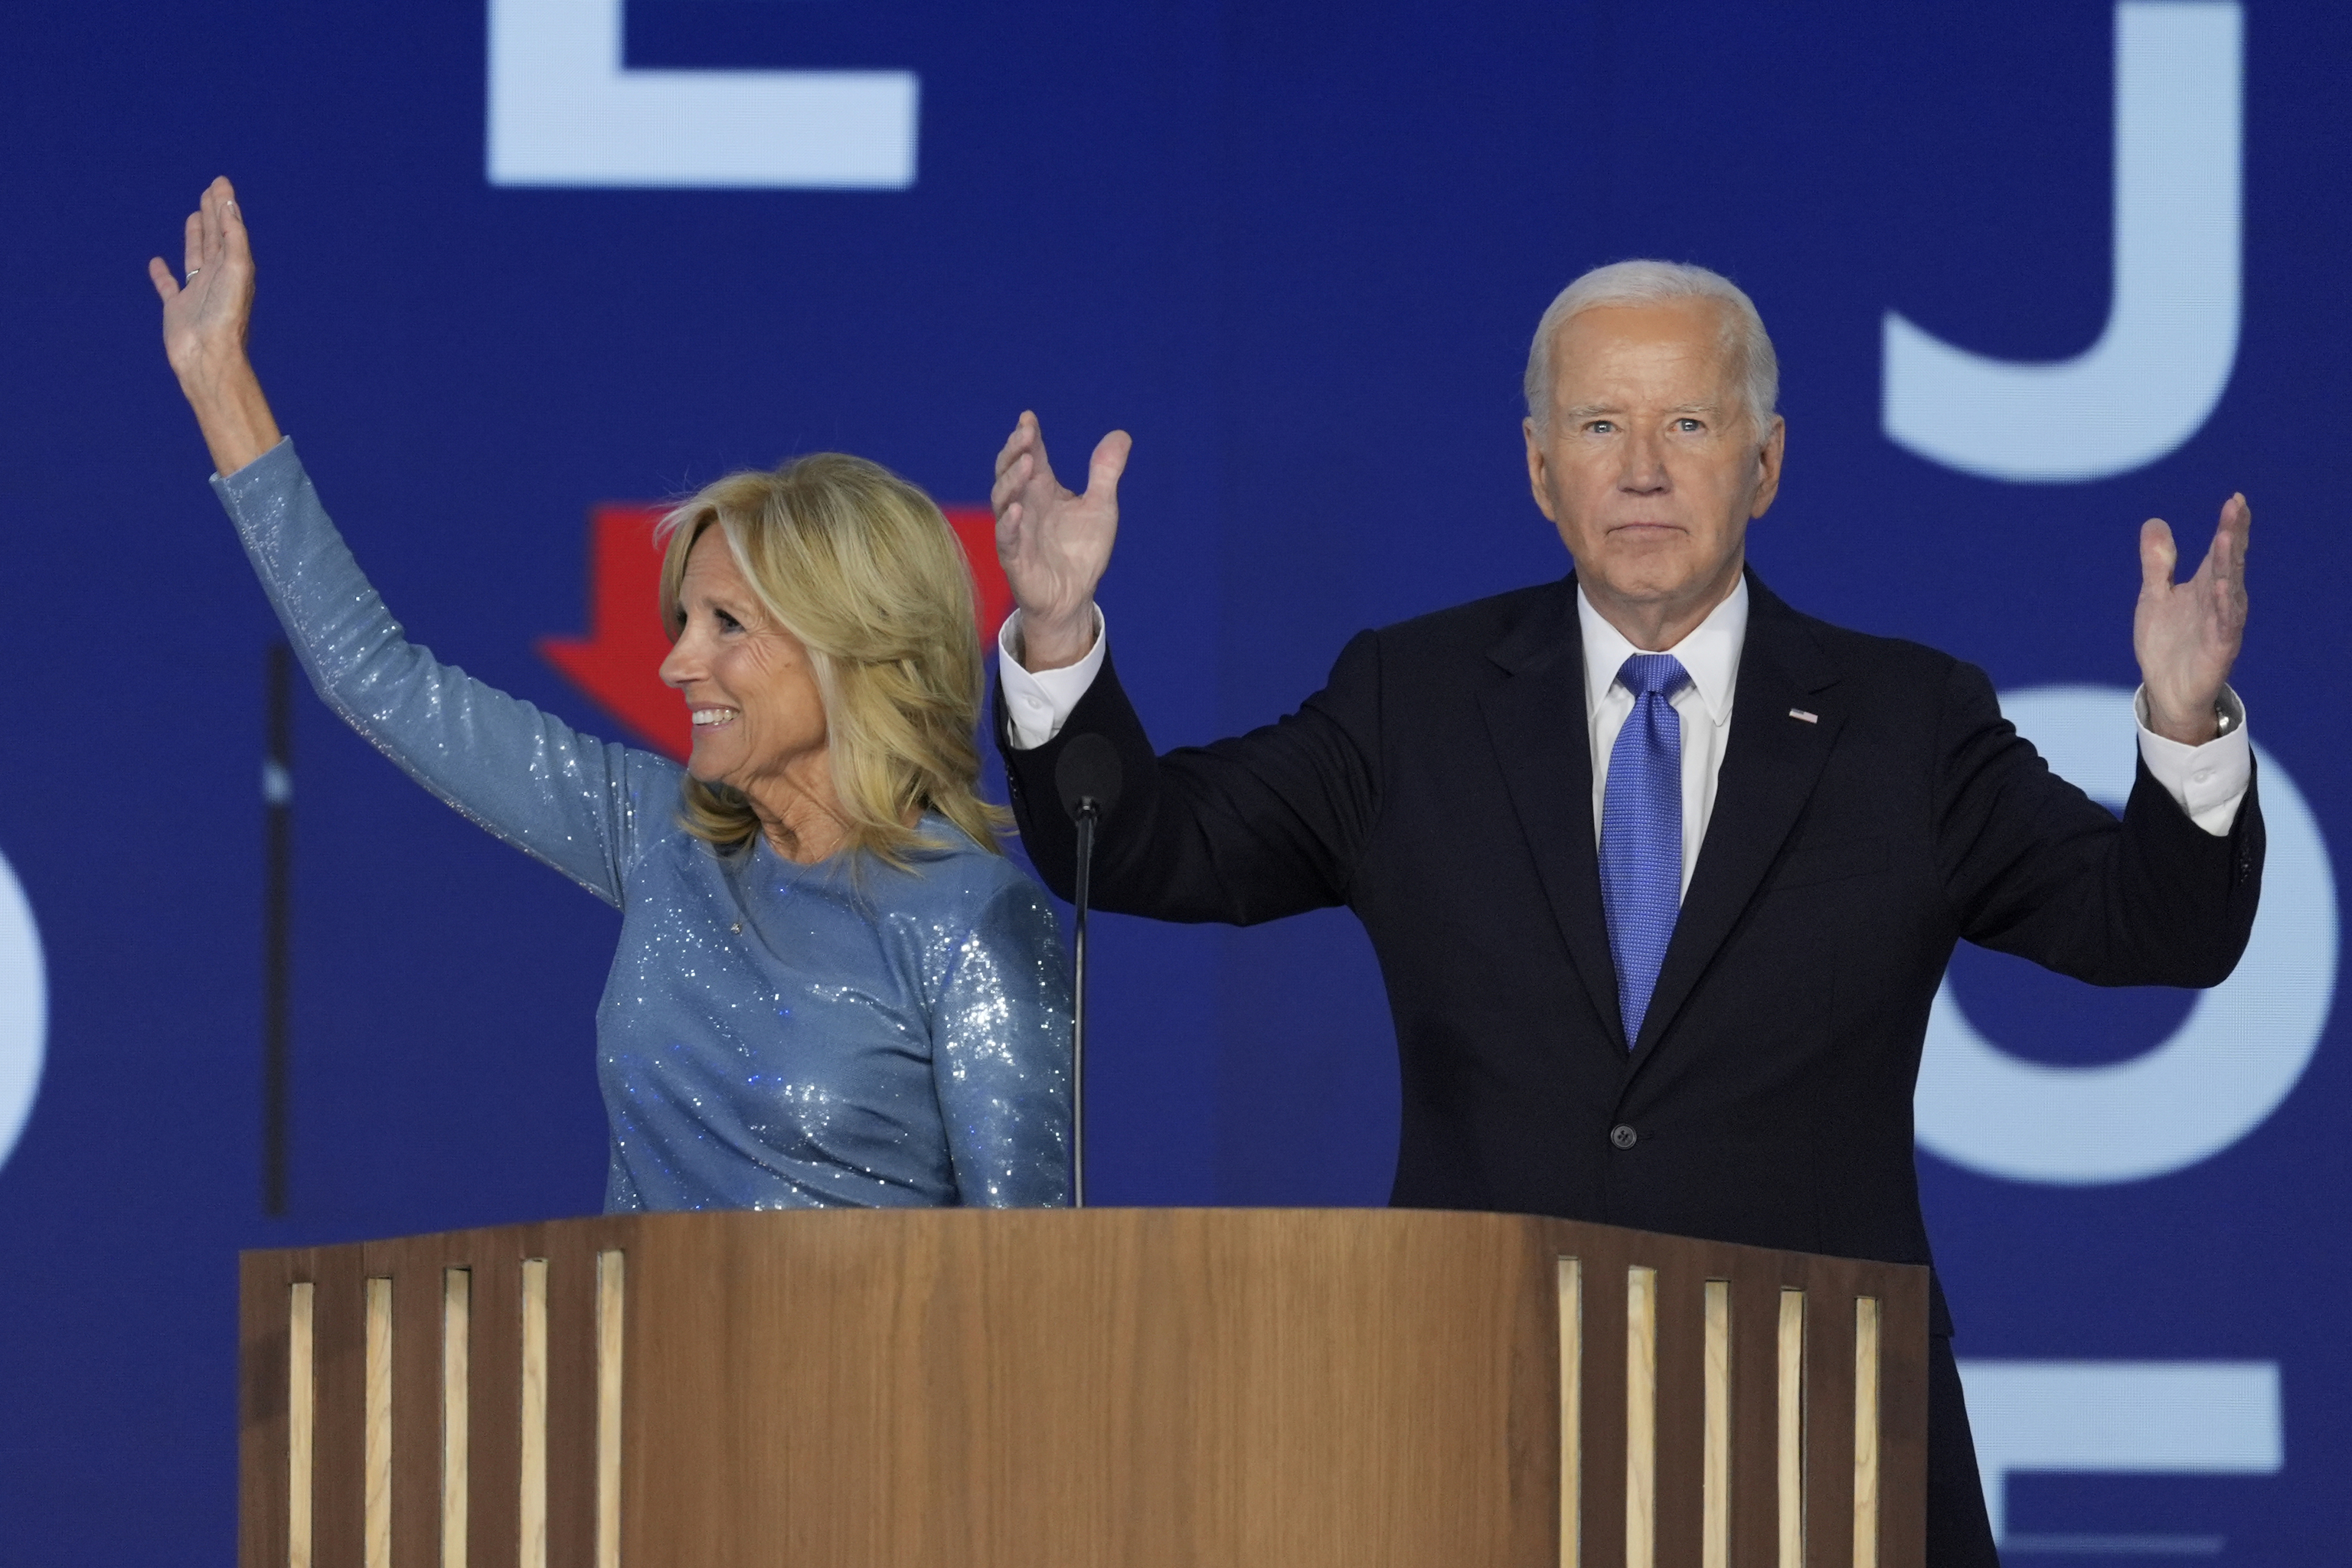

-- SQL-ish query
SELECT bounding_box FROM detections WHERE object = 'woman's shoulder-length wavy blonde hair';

[656,452,1011,867]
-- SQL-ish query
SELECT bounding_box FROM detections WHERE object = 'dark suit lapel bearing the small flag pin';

[1627,573,1841,1070]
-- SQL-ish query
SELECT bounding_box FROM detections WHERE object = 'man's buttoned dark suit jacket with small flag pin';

[1000,564,2262,1333]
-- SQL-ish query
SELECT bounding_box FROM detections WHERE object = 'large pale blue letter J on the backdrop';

[1882,0,2244,482]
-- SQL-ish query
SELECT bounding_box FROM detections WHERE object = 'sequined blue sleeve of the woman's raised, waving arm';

[211,439,678,905]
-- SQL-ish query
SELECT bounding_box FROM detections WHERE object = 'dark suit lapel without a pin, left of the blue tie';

[1479,576,1625,1050]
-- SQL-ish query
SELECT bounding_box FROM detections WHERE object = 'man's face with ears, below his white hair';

[1527,299,1783,613]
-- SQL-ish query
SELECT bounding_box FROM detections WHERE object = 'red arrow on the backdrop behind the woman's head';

[538,501,1014,762]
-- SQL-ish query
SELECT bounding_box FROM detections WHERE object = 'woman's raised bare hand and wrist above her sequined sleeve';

[149,176,277,475]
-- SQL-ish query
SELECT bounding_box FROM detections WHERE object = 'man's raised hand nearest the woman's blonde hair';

[990,413,1134,670]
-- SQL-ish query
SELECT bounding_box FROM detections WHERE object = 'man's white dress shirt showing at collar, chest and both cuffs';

[998,587,2253,893]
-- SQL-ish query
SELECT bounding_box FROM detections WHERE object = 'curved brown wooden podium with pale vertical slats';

[240,1208,1926,1568]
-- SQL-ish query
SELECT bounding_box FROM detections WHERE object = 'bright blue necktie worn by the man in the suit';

[1602,654,1691,1048]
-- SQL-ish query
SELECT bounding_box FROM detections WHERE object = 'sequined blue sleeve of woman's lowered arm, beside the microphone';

[932,867,1070,1208]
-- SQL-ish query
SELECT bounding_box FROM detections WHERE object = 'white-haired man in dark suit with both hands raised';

[995,261,2262,1568]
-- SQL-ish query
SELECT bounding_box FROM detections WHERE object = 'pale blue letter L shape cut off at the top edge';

[489,0,917,191]
